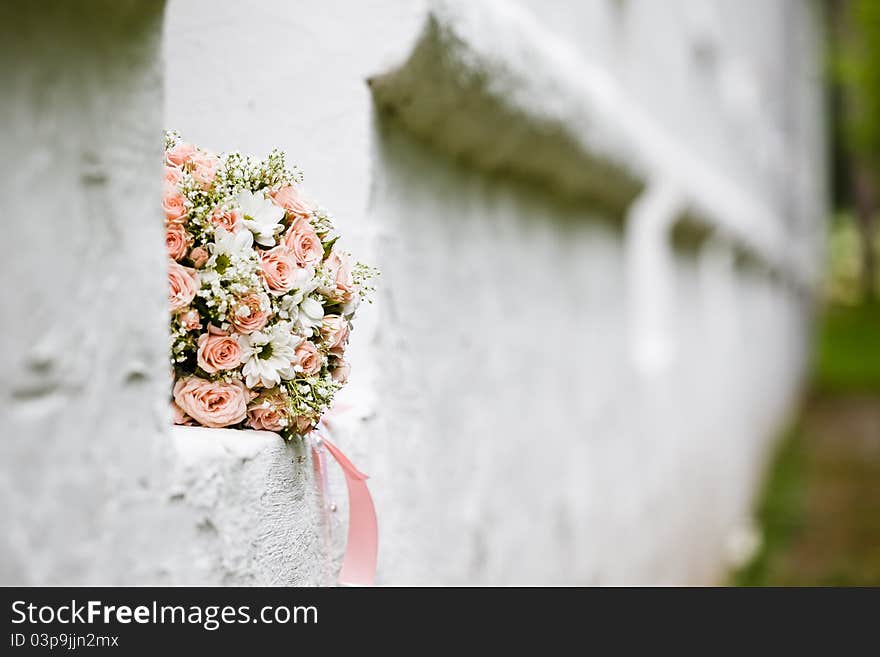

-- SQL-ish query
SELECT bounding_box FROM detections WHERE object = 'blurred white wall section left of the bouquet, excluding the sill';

[0,1,167,584]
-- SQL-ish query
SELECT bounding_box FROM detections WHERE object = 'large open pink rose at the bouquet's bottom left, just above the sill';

[174,376,248,428]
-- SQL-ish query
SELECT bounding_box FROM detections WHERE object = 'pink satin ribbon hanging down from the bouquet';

[312,427,379,586]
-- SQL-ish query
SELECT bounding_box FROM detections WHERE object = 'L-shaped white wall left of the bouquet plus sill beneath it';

[0,0,333,585]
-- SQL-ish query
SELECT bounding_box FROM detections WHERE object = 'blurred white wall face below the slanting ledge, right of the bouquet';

[361,124,807,584]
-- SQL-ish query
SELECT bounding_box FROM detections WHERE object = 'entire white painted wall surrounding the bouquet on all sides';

[0,0,824,584]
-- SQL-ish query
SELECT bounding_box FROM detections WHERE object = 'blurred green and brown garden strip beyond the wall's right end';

[730,0,880,586]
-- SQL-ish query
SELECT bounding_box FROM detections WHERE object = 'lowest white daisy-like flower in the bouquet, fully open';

[238,322,302,388]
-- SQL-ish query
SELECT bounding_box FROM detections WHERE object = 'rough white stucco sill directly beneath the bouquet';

[158,426,334,585]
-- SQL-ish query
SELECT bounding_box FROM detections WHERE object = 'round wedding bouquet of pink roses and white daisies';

[163,132,376,439]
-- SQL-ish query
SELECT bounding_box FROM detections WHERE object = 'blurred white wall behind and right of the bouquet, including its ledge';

[165,0,826,584]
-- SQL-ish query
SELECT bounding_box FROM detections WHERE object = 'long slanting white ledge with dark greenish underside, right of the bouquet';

[369,2,810,284]
